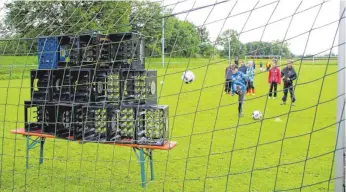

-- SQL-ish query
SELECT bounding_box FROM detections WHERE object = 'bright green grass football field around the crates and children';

[0,57,337,192]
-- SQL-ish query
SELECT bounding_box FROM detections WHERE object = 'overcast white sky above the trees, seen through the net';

[164,0,340,54]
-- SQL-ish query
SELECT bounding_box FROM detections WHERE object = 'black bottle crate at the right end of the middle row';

[121,70,157,105]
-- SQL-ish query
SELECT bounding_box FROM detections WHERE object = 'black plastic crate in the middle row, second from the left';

[51,68,73,102]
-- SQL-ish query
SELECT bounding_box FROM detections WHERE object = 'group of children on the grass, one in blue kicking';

[225,59,297,117]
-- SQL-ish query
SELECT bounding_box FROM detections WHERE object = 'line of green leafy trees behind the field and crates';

[0,1,292,58]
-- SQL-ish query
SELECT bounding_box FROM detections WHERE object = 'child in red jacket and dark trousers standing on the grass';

[268,59,281,99]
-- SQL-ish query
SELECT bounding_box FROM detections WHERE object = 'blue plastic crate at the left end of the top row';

[38,37,59,69]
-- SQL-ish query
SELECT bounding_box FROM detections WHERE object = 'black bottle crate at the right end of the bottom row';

[136,105,169,146]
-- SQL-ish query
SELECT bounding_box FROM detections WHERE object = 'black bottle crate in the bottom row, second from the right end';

[108,106,137,143]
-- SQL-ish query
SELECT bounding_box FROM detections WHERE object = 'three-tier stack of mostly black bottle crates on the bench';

[25,32,168,145]
